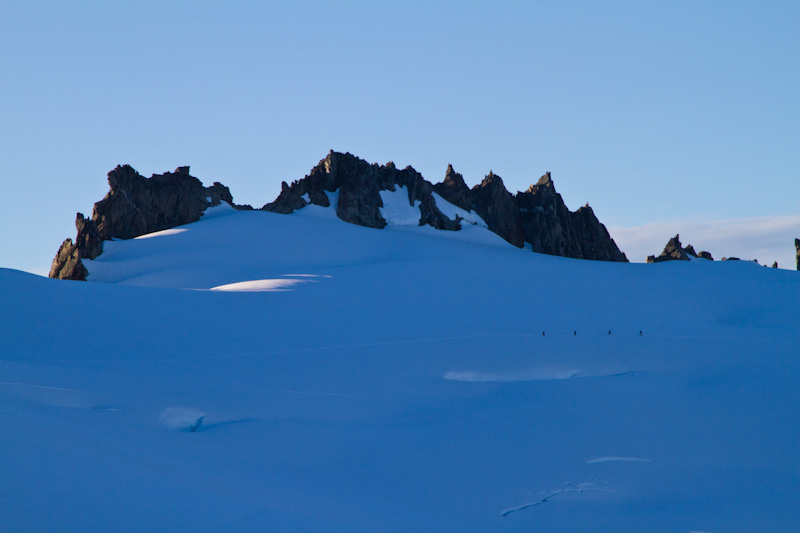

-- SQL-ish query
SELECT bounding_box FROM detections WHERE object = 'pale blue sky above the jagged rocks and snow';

[0,0,800,273]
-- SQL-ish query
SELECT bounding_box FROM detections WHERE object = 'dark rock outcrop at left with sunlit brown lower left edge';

[50,165,236,280]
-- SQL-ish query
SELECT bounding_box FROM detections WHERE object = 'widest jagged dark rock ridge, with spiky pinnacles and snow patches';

[263,151,627,262]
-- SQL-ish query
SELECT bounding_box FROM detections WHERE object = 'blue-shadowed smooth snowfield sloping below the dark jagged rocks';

[0,202,800,533]
